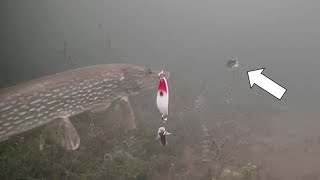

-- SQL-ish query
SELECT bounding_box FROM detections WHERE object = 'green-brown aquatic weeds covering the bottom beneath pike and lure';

[0,83,262,180]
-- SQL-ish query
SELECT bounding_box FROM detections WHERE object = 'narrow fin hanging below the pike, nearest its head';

[120,96,136,130]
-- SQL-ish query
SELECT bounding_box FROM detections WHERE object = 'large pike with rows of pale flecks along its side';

[0,64,168,150]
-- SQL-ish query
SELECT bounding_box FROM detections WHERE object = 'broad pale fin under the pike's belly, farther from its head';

[40,118,80,150]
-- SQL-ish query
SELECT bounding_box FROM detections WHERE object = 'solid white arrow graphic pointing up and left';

[248,68,287,99]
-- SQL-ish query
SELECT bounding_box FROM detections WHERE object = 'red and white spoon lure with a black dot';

[157,71,169,122]
